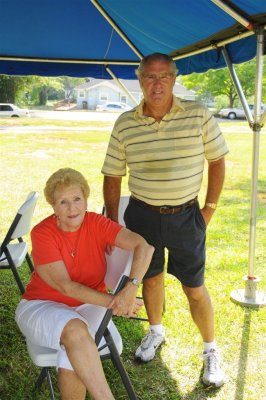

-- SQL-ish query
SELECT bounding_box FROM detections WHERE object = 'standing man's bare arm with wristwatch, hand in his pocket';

[201,157,225,225]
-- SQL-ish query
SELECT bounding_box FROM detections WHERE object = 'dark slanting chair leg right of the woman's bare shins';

[104,328,138,400]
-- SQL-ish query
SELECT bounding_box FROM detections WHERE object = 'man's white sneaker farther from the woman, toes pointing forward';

[202,349,224,387]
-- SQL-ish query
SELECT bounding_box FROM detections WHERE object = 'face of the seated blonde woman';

[53,185,87,232]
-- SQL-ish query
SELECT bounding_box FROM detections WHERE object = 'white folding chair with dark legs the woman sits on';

[26,248,137,400]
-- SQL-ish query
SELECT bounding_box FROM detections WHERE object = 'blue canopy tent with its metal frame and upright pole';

[0,0,266,305]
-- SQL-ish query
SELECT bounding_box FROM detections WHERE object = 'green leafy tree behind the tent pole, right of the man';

[182,57,266,107]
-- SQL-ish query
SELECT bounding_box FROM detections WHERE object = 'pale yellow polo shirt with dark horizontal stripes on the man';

[102,97,228,206]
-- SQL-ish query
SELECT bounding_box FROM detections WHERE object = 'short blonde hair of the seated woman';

[44,168,90,206]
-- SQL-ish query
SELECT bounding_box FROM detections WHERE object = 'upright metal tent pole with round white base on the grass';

[227,27,266,307]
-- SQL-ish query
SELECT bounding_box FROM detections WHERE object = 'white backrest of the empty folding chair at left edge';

[2,192,39,248]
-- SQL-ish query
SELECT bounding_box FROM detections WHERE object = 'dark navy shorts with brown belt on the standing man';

[124,197,206,288]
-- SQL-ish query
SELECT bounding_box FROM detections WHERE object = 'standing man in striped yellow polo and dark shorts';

[102,53,228,387]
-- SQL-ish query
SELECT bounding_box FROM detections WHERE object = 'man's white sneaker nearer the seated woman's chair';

[135,330,165,362]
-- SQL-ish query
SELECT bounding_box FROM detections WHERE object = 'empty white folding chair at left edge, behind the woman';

[0,192,39,294]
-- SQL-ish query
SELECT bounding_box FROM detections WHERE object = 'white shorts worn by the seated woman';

[15,300,122,371]
